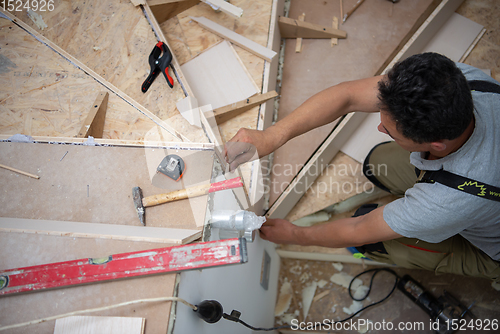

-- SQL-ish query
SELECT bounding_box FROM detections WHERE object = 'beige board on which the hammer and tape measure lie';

[0,142,213,229]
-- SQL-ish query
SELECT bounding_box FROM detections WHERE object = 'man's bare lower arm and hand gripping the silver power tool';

[260,207,402,248]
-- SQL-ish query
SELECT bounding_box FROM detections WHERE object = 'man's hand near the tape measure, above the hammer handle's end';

[224,128,276,171]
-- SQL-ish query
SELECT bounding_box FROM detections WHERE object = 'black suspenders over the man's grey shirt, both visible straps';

[417,80,500,202]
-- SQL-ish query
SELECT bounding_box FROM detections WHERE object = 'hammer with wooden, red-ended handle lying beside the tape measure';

[132,177,243,226]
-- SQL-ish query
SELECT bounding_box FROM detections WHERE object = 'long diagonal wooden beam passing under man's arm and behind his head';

[266,0,463,218]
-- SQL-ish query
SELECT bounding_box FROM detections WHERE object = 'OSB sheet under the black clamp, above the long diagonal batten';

[9,0,207,142]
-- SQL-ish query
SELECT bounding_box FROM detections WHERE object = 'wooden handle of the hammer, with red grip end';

[142,177,243,207]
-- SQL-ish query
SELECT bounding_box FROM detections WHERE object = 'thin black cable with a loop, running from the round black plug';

[223,268,400,331]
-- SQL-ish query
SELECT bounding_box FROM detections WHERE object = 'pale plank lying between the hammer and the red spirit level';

[0,217,201,245]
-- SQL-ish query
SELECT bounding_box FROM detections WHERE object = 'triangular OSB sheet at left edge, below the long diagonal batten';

[0,19,175,141]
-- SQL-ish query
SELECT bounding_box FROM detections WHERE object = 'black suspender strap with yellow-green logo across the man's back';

[417,169,500,202]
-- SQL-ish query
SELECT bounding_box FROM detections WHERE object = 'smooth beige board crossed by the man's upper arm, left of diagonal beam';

[270,0,432,204]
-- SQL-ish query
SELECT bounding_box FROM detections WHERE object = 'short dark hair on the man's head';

[378,52,474,143]
